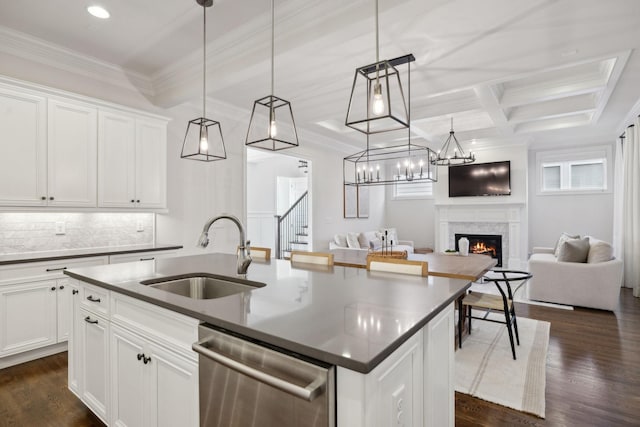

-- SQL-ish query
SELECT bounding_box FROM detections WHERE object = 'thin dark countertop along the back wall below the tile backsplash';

[0,244,182,265]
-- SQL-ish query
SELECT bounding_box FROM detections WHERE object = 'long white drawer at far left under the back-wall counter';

[0,256,108,285]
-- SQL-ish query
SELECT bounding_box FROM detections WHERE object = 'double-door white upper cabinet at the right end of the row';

[98,111,167,209]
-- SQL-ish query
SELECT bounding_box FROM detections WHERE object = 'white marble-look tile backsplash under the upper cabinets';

[0,212,155,255]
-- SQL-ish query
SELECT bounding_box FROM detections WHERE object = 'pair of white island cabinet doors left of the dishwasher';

[110,326,198,427]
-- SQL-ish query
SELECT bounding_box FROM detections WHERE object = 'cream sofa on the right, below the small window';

[528,238,622,310]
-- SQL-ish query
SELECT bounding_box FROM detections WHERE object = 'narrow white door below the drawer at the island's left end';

[79,308,109,424]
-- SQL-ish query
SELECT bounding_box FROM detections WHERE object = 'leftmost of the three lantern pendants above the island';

[180,0,227,162]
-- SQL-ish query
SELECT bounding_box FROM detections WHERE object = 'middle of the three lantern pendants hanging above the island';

[245,0,298,151]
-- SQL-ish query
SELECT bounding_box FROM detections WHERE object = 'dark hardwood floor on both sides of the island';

[0,289,640,427]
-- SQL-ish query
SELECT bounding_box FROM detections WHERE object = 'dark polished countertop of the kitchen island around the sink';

[65,254,470,373]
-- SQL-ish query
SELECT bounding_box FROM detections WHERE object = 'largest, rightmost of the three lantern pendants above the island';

[345,0,415,134]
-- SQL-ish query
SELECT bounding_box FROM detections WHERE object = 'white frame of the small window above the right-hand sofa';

[536,146,613,196]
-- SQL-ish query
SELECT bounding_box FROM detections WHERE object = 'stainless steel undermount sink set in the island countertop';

[140,273,265,299]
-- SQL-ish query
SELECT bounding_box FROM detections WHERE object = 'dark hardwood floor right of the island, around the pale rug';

[456,289,640,427]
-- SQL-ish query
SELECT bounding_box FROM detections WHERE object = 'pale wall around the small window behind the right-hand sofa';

[529,143,616,249]
